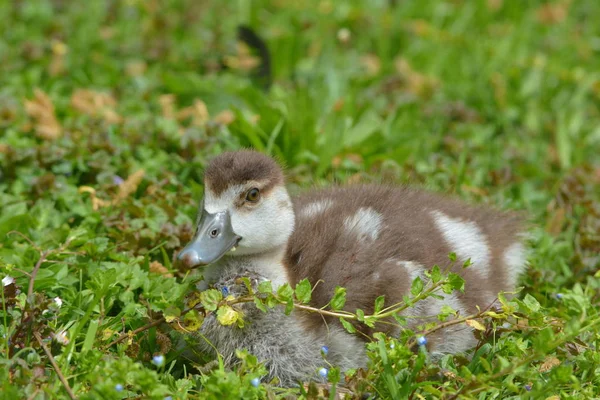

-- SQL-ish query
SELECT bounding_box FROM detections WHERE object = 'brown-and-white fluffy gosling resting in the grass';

[178,150,526,380]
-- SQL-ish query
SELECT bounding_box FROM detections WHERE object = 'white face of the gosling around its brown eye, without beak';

[204,182,294,255]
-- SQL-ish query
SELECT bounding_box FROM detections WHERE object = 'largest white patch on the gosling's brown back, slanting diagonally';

[432,211,491,278]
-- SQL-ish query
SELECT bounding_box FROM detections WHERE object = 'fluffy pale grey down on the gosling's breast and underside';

[190,258,365,386]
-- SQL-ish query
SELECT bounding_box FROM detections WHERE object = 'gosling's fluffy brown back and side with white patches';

[286,185,525,346]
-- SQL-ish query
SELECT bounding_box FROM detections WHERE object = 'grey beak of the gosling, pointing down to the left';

[177,211,242,268]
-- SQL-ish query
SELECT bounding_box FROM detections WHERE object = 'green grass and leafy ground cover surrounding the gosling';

[0,0,600,399]
